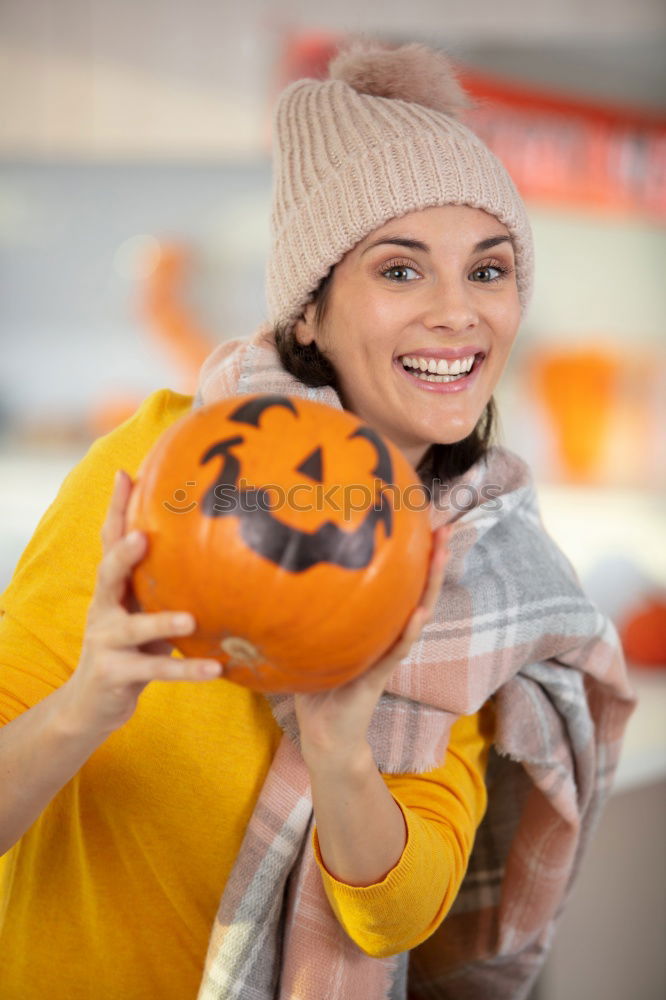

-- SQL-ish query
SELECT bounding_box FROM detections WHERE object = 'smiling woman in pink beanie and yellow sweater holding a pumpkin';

[0,39,631,1000]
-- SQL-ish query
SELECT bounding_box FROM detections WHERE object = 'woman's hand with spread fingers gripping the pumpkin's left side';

[60,471,222,737]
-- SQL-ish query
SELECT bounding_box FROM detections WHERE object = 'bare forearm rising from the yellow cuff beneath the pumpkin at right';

[307,744,407,886]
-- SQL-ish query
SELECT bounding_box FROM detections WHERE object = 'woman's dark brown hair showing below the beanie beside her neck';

[274,268,497,489]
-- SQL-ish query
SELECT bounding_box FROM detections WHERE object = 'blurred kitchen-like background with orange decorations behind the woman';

[0,0,666,1000]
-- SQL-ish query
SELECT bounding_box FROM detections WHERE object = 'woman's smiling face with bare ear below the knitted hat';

[295,205,520,465]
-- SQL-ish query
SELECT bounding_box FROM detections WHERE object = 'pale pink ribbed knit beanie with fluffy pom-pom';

[266,42,533,325]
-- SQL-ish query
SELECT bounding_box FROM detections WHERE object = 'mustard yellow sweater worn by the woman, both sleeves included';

[0,390,492,1000]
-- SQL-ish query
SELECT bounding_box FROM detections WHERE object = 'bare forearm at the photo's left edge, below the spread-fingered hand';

[0,686,104,855]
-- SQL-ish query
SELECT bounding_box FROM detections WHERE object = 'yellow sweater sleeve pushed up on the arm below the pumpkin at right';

[313,703,494,958]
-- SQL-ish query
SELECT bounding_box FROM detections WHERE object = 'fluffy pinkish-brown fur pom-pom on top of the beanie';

[329,41,473,118]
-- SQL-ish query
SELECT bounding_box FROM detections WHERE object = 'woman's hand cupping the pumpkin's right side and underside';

[295,525,452,767]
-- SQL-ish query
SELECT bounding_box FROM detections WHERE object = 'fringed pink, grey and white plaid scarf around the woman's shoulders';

[194,328,634,1000]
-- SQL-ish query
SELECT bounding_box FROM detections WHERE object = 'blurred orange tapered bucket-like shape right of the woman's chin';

[532,347,620,482]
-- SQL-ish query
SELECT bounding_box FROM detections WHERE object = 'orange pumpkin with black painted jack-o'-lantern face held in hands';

[128,395,432,692]
